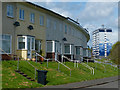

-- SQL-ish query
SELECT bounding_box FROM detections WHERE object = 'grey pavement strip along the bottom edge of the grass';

[43,76,118,89]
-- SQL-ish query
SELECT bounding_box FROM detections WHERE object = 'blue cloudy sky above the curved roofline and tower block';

[28,0,119,47]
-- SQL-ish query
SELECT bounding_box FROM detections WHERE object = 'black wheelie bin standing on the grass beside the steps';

[37,70,48,85]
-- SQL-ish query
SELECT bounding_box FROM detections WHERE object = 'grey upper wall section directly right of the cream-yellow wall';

[46,14,63,43]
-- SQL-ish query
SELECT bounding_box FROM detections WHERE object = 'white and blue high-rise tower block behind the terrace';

[92,28,112,58]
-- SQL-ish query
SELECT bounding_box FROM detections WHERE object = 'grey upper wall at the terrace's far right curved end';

[63,22,87,48]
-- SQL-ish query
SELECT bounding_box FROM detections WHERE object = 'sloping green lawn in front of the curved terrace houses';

[2,61,118,88]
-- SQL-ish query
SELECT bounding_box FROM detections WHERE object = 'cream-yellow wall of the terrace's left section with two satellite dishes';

[2,2,46,59]
